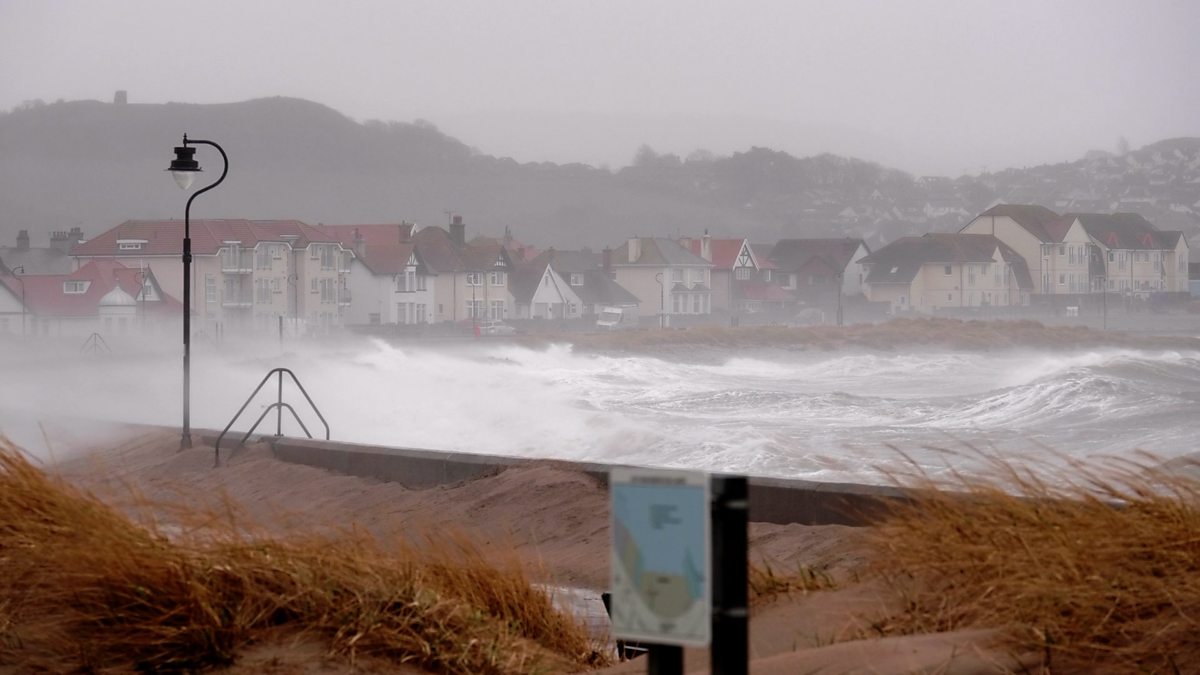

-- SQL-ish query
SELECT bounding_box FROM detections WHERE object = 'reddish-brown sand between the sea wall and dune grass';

[32,428,1036,674]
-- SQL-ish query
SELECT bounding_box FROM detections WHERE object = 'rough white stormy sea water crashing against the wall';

[4,341,1200,482]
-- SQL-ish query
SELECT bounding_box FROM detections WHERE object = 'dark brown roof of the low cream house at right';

[859,233,1033,288]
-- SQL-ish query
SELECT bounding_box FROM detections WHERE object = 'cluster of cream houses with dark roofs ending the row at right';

[859,204,1189,313]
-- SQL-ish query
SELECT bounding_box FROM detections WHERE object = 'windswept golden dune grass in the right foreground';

[874,451,1200,673]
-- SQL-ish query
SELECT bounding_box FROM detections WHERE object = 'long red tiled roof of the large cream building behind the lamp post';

[71,220,337,257]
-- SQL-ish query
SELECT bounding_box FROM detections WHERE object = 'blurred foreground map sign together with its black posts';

[604,467,750,675]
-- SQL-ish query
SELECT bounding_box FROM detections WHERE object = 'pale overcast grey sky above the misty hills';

[0,0,1200,175]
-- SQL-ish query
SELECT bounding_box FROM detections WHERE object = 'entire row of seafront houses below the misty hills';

[0,204,1188,335]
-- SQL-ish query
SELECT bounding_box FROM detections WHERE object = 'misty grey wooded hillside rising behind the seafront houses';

[0,98,1200,246]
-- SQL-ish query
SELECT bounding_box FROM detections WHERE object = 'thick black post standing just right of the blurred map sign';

[710,476,750,675]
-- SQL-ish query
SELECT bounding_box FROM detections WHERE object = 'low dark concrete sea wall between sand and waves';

[238,434,905,525]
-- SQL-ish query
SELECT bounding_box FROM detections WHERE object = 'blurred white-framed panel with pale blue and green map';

[608,468,712,645]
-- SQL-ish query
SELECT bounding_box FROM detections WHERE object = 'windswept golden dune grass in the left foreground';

[0,441,604,674]
